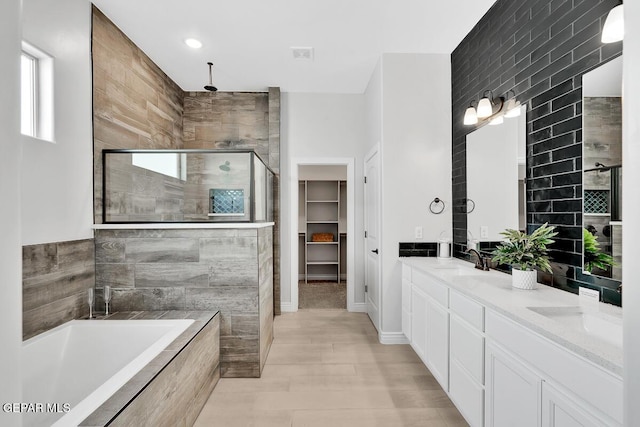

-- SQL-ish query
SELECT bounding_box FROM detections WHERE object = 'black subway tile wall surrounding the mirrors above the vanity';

[451,0,622,304]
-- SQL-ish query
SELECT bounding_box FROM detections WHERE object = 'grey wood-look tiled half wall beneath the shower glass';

[95,227,273,377]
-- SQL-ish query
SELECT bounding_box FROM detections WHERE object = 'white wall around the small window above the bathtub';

[22,0,93,245]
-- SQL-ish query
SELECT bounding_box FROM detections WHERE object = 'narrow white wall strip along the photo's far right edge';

[622,1,640,427]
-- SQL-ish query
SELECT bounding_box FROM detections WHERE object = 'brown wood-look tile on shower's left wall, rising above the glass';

[92,6,184,224]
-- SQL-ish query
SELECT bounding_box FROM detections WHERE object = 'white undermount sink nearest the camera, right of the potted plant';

[527,306,622,347]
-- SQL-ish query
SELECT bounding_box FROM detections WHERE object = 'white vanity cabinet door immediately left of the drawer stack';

[425,298,449,391]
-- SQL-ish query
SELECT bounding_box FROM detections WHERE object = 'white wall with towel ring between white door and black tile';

[376,54,452,342]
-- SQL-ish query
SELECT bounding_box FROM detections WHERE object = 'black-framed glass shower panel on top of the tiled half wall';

[102,149,275,224]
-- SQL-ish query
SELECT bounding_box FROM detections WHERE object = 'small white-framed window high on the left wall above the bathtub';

[20,42,53,141]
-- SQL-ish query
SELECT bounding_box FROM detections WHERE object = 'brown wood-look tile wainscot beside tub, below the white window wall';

[22,239,95,339]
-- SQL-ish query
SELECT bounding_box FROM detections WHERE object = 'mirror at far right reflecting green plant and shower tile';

[582,56,622,280]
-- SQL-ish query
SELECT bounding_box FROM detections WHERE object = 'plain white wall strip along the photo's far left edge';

[0,0,22,425]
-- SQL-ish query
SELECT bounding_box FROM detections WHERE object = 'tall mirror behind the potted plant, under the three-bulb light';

[466,106,527,248]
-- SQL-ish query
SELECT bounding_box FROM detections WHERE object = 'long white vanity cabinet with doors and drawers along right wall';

[402,260,622,427]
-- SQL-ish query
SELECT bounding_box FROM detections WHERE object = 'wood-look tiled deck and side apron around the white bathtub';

[80,310,220,427]
